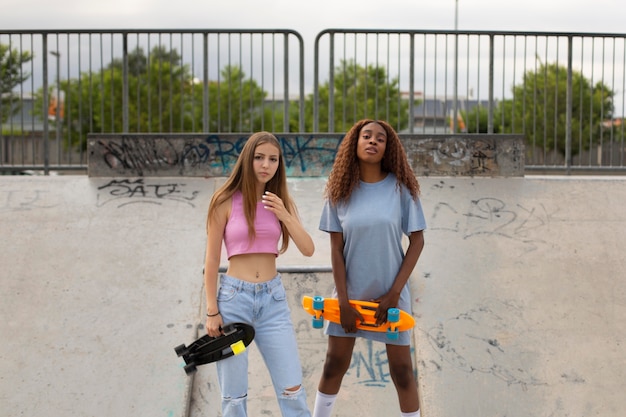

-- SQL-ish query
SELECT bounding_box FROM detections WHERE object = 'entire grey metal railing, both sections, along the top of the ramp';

[0,29,626,173]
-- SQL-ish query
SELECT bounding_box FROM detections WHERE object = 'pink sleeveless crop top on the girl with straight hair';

[224,191,282,259]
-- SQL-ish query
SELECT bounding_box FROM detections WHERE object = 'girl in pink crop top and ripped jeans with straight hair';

[204,132,315,417]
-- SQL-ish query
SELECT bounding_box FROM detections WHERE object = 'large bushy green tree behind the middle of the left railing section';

[61,47,193,138]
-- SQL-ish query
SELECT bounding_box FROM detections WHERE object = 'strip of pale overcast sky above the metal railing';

[0,0,626,38]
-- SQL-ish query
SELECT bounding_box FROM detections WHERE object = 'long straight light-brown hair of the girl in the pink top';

[207,132,297,253]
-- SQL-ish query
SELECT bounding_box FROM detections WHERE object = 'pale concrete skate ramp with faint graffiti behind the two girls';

[0,176,626,417]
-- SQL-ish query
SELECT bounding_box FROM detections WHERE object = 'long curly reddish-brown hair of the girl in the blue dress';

[325,119,420,204]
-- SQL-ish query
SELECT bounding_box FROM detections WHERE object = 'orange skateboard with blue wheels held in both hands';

[302,295,415,340]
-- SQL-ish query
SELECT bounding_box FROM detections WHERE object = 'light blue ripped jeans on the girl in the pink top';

[216,274,311,417]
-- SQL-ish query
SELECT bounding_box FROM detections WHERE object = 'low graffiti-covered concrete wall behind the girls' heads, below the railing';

[88,133,525,177]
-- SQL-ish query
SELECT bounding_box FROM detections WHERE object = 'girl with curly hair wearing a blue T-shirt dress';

[313,119,426,417]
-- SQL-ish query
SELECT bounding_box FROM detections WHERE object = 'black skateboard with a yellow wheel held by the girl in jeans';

[174,323,254,375]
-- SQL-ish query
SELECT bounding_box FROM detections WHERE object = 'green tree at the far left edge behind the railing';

[0,44,33,122]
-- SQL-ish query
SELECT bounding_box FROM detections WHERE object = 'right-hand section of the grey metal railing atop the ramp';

[314,29,626,172]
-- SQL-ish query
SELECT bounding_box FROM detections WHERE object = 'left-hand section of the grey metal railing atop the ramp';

[0,29,304,172]
